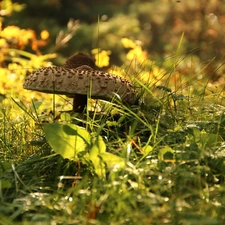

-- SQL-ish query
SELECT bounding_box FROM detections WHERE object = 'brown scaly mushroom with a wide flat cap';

[23,53,136,112]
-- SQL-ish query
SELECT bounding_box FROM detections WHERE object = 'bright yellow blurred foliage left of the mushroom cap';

[0,19,59,114]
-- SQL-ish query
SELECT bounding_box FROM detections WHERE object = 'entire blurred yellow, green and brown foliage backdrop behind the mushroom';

[0,0,225,111]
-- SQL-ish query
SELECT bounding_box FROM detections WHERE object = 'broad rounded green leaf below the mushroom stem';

[44,123,91,160]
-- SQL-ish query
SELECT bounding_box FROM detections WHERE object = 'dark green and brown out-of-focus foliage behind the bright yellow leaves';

[2,0,225,81]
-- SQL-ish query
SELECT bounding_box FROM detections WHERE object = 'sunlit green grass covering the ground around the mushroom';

[0,55,225,225]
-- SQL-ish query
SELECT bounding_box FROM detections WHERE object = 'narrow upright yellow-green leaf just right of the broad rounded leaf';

[89,136,106,178]
